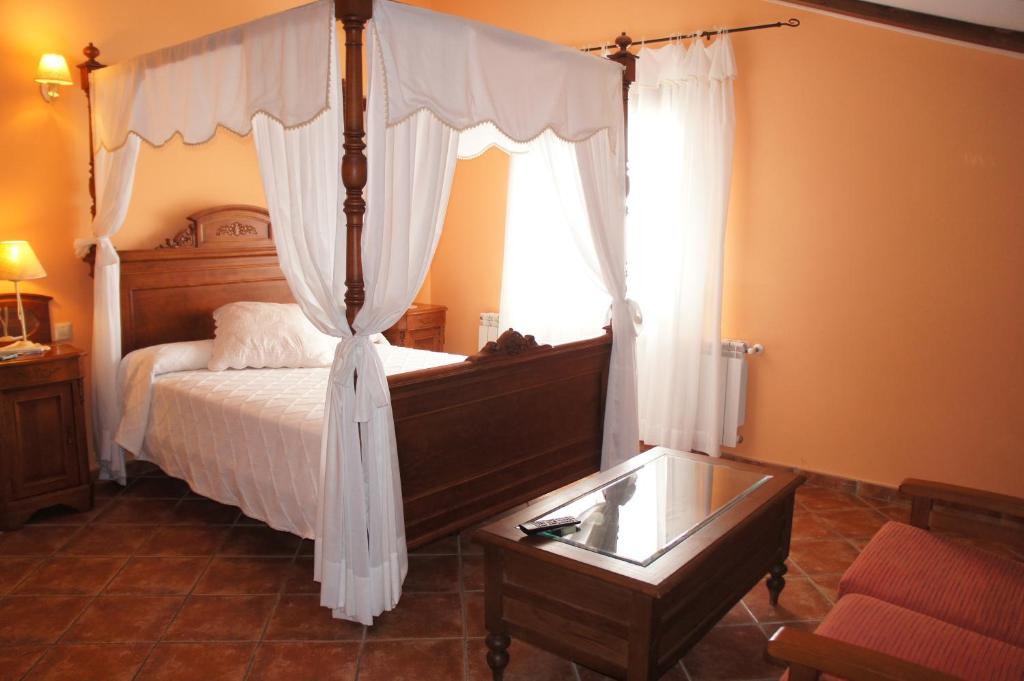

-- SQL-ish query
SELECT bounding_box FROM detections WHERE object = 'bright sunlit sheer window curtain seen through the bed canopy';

[495,134,611,344]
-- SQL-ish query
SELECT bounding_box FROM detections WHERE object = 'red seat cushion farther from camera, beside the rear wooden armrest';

[839,522,1024,647]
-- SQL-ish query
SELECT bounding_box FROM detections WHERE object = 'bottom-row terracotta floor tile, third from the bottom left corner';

[135,643,255,681]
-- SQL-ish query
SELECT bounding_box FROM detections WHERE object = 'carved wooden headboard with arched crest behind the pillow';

[113,206,295,354]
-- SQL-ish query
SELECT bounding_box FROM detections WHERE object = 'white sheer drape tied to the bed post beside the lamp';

[75,135,139,484]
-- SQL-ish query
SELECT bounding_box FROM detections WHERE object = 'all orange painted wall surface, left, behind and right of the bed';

[0,0,1024,496]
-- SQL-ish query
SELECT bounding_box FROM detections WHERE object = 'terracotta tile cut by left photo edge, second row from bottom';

[0,596,89,645]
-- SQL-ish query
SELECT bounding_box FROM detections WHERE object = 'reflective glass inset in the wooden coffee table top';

[535,450,771,565]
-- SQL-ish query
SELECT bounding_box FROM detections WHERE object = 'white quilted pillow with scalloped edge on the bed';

[208,302,338,372]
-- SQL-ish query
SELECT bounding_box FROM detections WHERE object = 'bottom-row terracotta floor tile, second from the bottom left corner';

[26,643,151,681]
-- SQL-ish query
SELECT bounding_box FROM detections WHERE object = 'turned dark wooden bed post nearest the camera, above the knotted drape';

[334,0,373,325]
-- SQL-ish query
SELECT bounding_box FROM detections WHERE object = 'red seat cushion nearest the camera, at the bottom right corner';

[814,594,1024,681]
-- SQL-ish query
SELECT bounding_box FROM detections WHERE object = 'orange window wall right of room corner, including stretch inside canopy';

[432,0,1024,496]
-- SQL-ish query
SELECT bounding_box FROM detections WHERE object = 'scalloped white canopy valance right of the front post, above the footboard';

[370,2,623,146]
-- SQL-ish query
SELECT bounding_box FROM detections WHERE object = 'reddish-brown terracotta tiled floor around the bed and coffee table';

[0,466,1009,681]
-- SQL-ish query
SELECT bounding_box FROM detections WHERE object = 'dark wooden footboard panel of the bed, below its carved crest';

[388,333,611,548]
